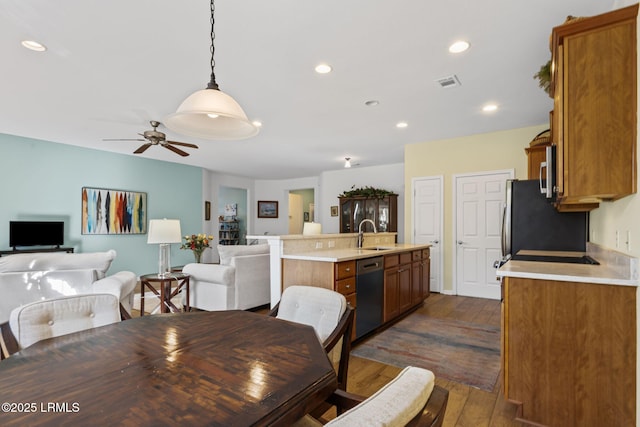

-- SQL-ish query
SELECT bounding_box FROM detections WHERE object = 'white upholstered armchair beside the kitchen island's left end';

[182,244,270,311]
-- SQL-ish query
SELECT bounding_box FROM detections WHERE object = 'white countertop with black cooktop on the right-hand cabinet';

[497,247,640,286]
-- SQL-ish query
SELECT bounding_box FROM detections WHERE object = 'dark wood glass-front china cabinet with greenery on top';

[339,194,398,233]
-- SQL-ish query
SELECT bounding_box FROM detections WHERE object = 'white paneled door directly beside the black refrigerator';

[454,171,513,299]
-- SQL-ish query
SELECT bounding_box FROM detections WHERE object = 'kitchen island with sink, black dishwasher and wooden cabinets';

[247,233,430,339]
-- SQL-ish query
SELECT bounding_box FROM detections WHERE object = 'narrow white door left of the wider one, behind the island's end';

[413,176,443,292]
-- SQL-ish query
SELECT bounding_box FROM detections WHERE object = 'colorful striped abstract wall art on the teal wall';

[82,187,147,234]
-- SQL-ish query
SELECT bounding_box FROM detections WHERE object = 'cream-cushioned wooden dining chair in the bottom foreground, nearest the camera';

[294,366,449,427]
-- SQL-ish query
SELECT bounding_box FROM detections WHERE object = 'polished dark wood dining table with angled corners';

[0,311,337,426]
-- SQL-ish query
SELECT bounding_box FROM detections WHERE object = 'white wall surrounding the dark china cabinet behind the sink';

[316,163,405,239]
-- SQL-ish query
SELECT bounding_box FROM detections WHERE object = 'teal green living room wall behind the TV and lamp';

[0,134,203,275]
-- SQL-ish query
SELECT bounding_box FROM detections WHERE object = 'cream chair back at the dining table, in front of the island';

[276,286,347,343]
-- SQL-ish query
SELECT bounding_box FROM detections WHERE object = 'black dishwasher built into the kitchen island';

[356,256,384,339]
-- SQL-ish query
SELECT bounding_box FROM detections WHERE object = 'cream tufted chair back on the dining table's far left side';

[9,294,120,349]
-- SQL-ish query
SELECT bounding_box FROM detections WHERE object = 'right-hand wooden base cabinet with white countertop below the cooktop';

[497,244,638,426]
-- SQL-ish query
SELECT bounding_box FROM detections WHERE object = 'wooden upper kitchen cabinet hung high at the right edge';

[551,4,638,210]
